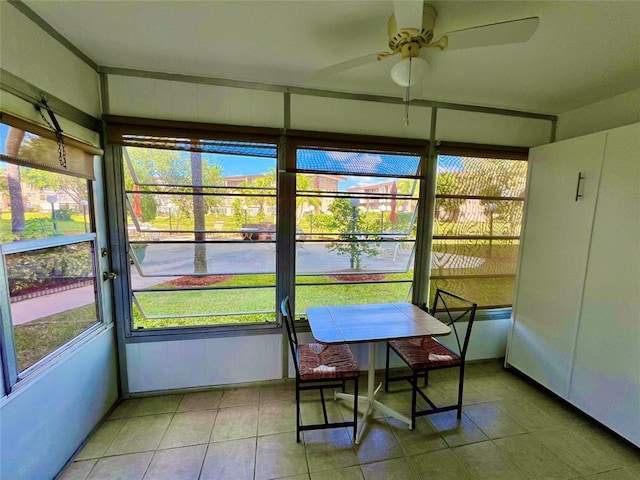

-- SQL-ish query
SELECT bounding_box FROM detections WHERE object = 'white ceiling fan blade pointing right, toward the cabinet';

[445,17,540,50]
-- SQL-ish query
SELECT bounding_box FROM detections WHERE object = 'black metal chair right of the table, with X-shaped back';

[385,289,478,429]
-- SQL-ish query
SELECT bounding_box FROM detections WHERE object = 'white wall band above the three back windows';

[108,75,551,147]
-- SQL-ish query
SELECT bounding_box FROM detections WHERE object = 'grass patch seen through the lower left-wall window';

[13,304,97,372]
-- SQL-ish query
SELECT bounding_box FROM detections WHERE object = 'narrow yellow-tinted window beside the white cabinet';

[430,155,527,308]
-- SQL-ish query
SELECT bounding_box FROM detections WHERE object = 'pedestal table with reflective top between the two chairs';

[307,303,451,444]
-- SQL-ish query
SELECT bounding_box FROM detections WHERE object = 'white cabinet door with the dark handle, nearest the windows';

[507,133,606,398]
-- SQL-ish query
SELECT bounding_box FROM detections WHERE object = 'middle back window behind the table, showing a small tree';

[295,145,421,313]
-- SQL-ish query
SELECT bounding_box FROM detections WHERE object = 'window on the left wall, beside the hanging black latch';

[0,115,101,380]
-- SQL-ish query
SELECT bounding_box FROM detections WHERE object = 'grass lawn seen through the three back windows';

[133,255,514,328]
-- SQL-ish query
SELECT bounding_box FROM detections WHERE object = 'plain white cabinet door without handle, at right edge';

[569,124,640,446]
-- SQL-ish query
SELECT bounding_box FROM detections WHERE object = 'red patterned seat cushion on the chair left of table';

[298,343,360,380]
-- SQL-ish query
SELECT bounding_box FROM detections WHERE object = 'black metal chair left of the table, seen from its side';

[280,297,360,442]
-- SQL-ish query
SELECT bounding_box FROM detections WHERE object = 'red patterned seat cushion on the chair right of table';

[389,337,462,370]
